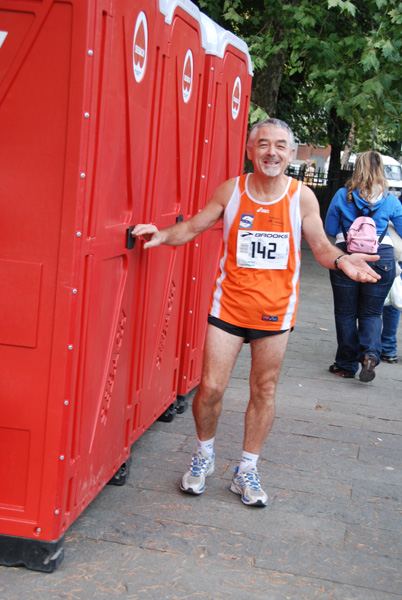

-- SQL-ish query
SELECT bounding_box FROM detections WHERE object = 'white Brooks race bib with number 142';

[236,230,290,269]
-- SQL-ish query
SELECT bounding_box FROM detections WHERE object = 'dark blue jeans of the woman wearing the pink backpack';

[329,244,395,375]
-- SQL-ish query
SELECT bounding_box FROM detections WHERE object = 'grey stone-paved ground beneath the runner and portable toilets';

[0,240,402,600]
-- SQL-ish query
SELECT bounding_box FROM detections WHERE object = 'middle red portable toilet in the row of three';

[131,0,209,430]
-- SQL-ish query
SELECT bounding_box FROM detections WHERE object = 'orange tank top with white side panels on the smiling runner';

[210,174,302,331]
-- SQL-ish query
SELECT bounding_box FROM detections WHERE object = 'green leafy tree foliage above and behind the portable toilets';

[198,0,402,166]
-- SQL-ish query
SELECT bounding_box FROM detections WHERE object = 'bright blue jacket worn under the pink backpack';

[325,187,402,243]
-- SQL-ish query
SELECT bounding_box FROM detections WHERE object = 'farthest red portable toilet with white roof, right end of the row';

[177,14,252,410]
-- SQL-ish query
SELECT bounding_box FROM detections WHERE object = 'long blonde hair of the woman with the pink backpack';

[346,150,388,203]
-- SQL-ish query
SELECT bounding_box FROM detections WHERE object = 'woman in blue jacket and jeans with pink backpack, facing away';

[325,150,402,382]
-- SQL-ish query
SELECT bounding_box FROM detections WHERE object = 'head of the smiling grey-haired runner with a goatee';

[247,125,295,177]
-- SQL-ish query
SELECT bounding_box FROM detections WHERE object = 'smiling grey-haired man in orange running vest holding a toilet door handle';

[132,119,379,506]
